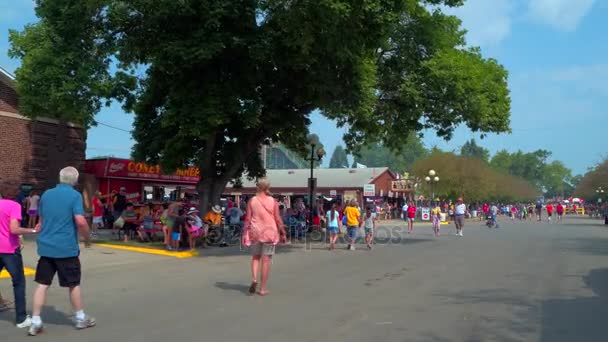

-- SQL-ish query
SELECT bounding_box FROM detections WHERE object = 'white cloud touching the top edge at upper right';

[528,0,596,31]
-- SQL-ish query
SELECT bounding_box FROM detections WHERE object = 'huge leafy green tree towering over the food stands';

[10,0,510,211]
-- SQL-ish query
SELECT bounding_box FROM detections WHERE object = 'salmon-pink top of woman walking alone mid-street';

[243,196,280,246]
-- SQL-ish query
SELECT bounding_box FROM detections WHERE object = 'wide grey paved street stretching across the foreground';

[0,218,608,342]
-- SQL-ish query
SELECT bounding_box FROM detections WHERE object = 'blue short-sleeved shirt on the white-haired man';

[38,184,84,258]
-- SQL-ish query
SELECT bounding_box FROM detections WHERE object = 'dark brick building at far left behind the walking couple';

[0,68,86,197]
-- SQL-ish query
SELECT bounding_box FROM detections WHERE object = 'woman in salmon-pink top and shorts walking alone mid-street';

[242,178,286,296]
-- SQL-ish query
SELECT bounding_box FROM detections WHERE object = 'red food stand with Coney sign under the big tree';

[85,158,200,203]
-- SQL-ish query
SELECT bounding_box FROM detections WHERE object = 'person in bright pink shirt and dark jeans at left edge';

[0,199,36,329]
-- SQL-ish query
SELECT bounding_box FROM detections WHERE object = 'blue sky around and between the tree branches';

[0,0,608,173]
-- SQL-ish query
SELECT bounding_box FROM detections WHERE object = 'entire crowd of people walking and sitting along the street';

[0,167,608,336]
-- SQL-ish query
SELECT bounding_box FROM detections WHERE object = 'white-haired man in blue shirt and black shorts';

[28,166,95,336]
